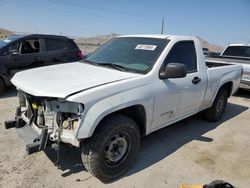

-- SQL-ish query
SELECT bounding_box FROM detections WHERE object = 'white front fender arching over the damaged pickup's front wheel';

[76,88,154,139]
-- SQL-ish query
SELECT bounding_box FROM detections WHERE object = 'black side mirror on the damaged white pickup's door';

[159,63,187,80]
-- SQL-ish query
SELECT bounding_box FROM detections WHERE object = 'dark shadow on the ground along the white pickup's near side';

[121,103,248,181]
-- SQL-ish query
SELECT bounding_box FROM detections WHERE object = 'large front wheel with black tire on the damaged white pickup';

[81,115,140,182]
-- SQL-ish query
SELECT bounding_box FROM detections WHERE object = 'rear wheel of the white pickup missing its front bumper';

[204,88,228,122]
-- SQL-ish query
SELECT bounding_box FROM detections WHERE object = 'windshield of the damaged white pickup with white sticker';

[85,37,168,74]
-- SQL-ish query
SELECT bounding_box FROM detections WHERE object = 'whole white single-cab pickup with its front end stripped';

[5,35,242,182]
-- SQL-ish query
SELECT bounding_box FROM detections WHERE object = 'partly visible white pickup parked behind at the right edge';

[207,44,250,90]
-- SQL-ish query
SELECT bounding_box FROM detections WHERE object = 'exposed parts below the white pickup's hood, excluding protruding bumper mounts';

[18,90,84,147]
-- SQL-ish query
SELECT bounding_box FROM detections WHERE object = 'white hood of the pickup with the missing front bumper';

[11,62,139,98]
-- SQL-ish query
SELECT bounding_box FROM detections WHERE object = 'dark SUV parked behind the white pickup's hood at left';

[0,34,82,93]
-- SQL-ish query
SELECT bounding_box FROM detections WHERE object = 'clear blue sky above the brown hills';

[0,0,250,46]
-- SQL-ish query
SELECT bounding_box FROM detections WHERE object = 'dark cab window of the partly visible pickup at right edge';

[222,46,250,58]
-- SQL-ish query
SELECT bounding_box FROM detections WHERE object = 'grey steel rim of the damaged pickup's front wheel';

[104,134,128,164]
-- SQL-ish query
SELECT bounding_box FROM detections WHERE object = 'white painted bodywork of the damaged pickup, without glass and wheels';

[12,35,241,139]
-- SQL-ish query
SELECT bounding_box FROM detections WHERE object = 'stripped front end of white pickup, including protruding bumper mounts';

[5,90,84,154]
